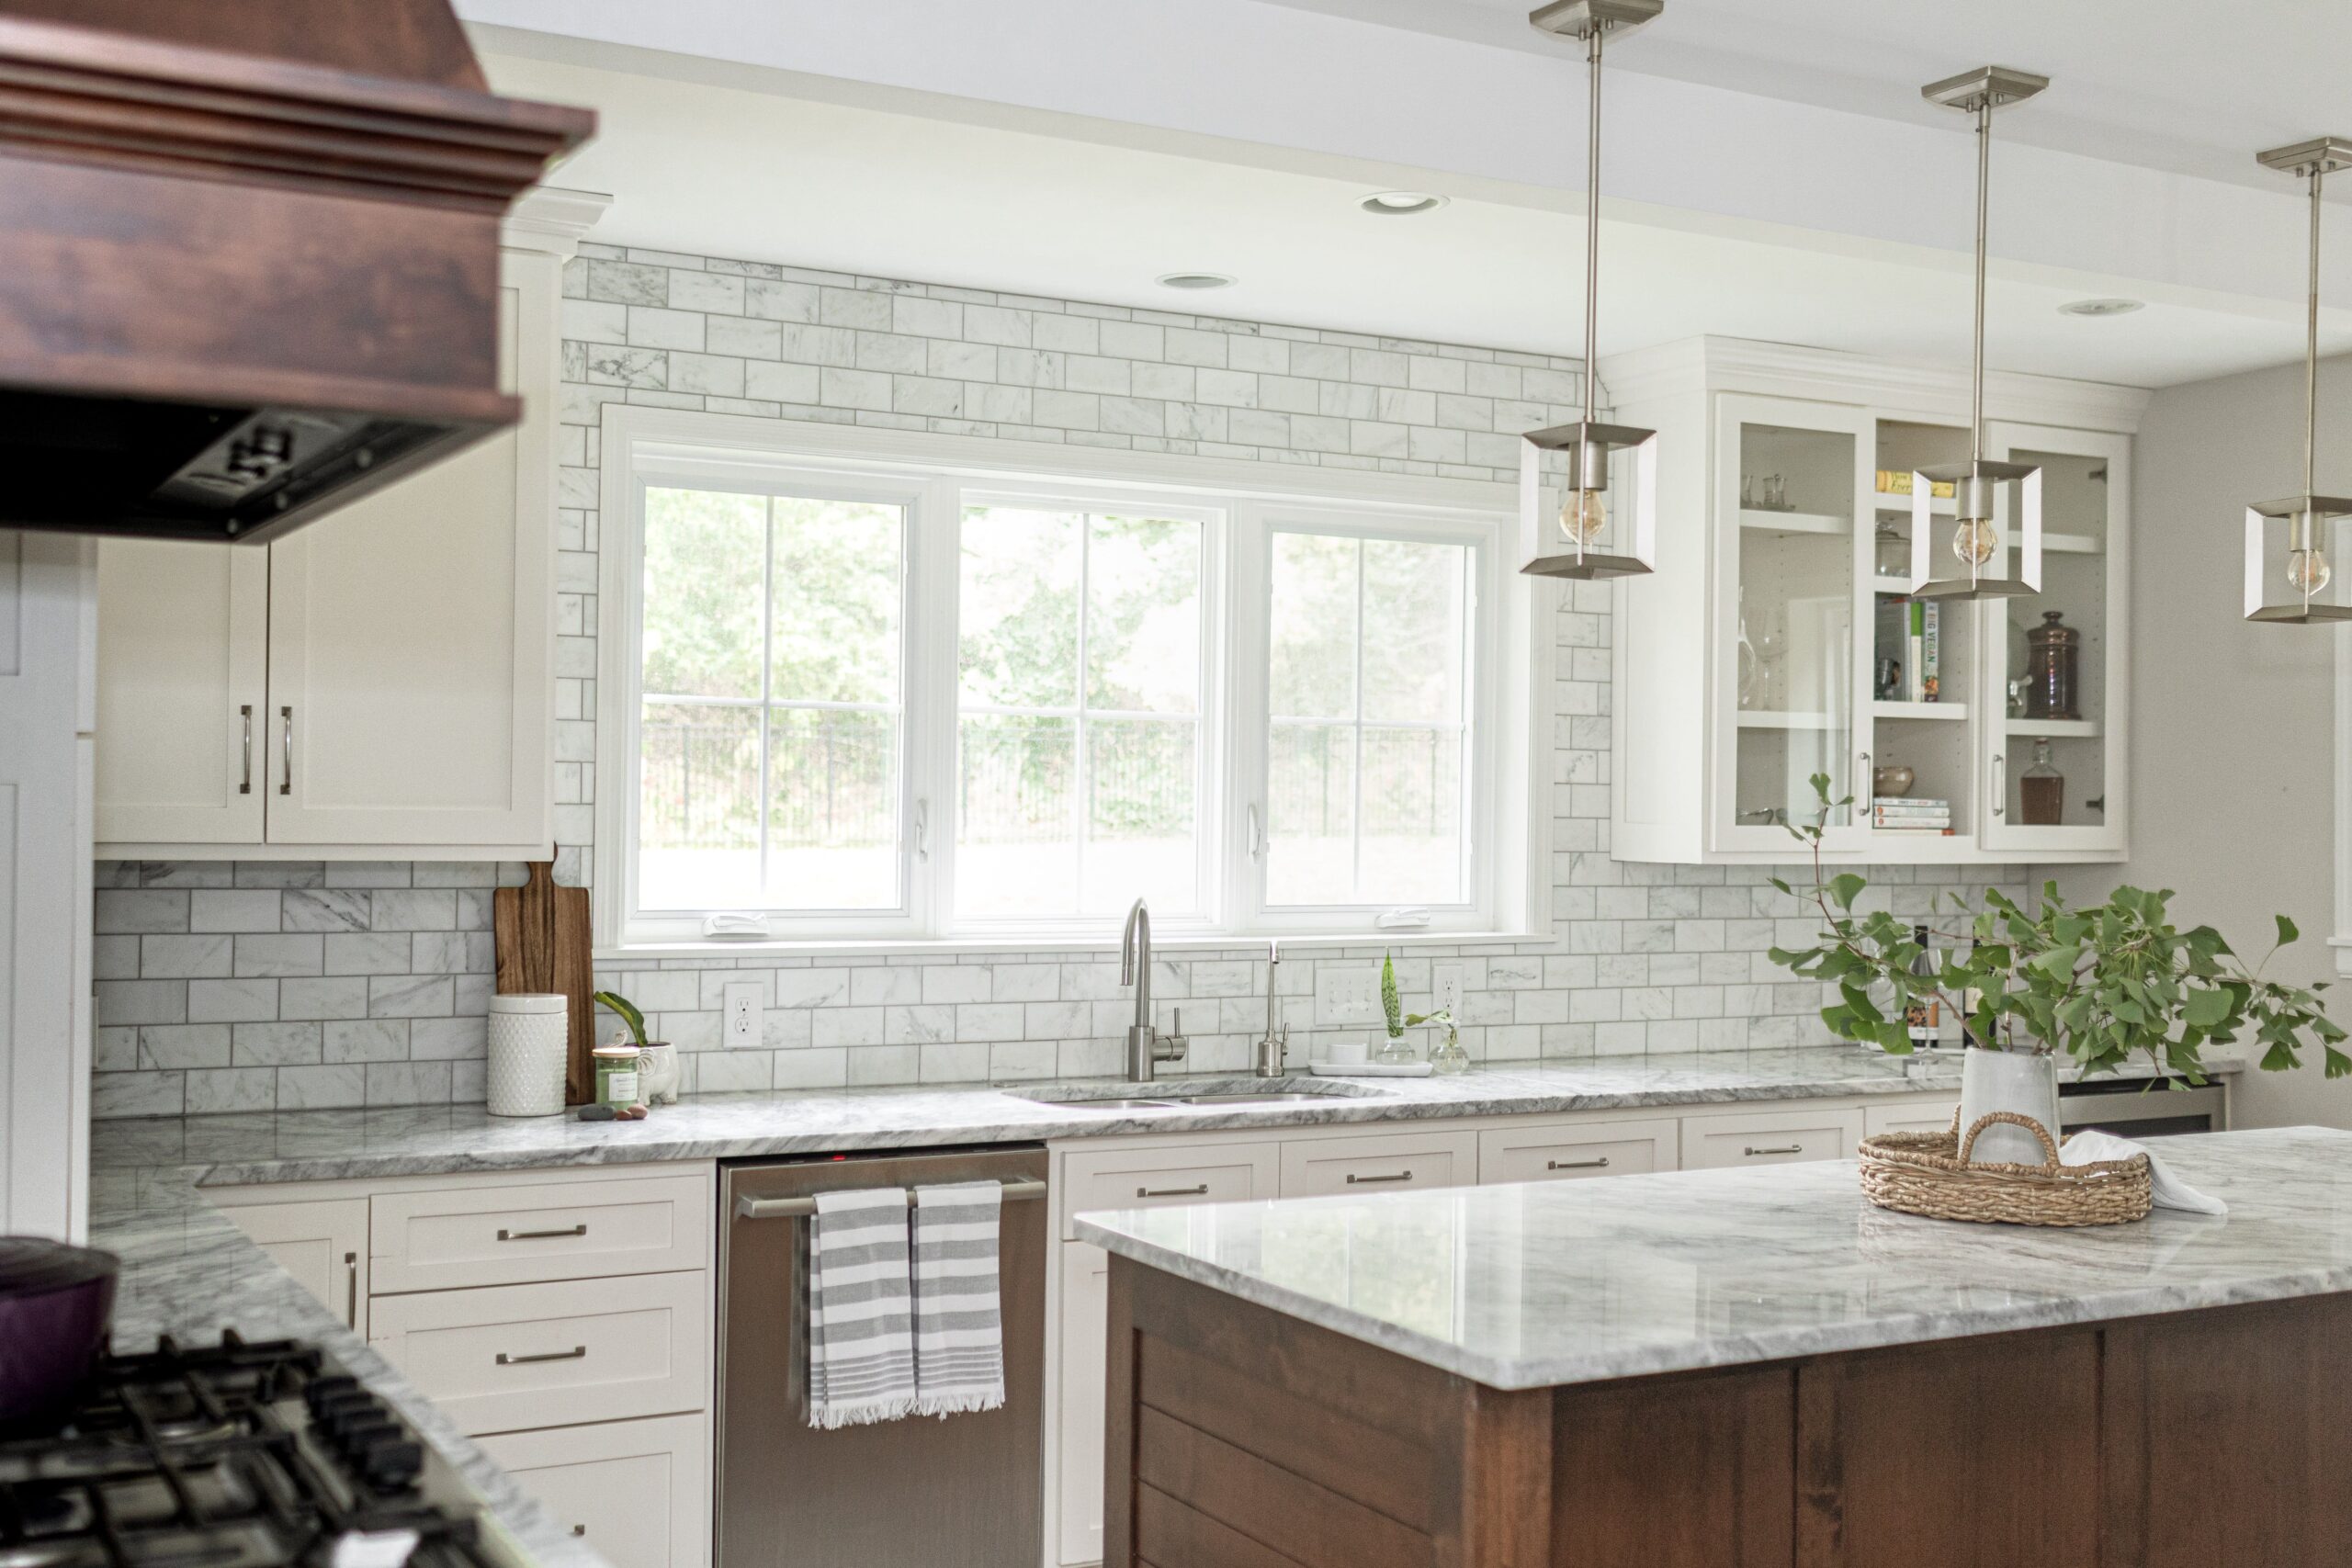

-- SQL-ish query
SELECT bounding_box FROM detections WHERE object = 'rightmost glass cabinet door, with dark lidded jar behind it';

[1978,425,2131,851]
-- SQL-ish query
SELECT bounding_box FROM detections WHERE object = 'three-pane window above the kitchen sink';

[605,446,1498,941]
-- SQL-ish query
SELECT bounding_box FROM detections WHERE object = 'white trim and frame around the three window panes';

[593,402,1562,957]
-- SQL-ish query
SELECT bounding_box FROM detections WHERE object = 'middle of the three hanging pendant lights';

[1910,66,2051,600]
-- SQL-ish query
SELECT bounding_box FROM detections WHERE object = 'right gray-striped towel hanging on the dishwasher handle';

[915,1182,1004,1417]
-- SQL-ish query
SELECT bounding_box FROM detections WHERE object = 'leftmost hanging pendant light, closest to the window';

[1520,0,1665,579]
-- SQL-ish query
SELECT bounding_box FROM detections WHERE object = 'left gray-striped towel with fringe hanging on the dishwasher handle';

[809,1187,915,1432]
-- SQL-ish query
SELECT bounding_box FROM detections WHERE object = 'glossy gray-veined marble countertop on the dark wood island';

[1077,1128,2352,1389]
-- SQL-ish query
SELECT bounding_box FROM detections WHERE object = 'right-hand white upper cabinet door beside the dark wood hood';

[266,252,558,856]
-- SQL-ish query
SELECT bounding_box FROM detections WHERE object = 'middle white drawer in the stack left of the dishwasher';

[367,1269,710,1437]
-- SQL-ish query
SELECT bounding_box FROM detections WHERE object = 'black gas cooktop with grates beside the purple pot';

[0,1333,526,1568]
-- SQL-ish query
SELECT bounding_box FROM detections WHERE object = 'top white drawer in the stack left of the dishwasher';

[367,1176,715,1295]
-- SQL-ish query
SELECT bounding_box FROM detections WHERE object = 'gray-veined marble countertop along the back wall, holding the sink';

[92,1046,2237,1185]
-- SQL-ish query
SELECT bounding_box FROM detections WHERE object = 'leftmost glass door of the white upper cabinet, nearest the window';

[1710,395,1872,851]
